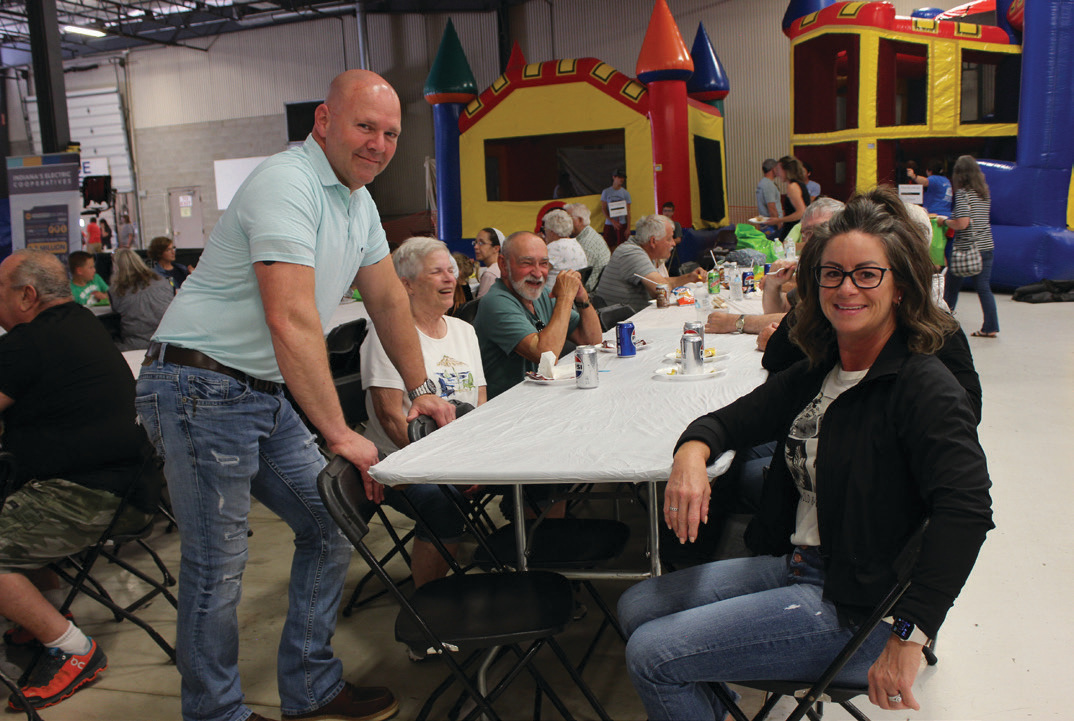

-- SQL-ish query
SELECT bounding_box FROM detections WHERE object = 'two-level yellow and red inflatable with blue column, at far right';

[783,0,1074,288]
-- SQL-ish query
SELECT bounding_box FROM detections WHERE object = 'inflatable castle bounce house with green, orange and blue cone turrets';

[425,0,728,262]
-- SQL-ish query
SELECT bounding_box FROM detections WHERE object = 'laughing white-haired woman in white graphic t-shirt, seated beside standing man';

[361,237,485,586]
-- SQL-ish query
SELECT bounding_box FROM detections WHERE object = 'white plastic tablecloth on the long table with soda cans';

[371,294,767,486]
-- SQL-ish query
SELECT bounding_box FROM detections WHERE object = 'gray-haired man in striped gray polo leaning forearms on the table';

[597,210,705,311]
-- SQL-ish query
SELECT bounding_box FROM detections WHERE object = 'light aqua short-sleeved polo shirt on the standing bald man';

[154,136,388,383]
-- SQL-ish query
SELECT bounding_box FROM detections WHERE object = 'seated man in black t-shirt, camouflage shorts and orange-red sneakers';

[0,250,156,708]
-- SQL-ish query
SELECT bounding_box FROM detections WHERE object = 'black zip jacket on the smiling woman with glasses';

[677,332,993,637]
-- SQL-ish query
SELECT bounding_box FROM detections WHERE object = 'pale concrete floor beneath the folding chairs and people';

[2,293,1074,721]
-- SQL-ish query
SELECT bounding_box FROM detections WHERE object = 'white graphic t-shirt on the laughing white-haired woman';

[361,316,485,456]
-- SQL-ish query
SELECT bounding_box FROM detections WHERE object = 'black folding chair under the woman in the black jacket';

[709,518,937,721]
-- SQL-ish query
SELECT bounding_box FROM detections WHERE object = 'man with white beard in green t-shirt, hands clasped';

[474,231,600,400]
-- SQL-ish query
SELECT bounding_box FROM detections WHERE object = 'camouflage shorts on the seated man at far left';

[0,478,149,573]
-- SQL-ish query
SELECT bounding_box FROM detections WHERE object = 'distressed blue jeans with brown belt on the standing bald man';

[135,361,351,721]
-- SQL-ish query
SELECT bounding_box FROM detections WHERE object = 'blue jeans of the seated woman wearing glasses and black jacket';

[619,549,891,721]
